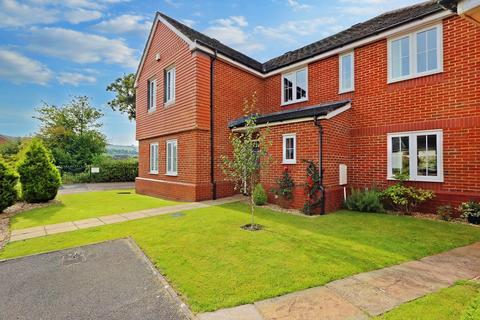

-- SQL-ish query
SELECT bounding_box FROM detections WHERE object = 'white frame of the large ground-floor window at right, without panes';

[387,129,444,182]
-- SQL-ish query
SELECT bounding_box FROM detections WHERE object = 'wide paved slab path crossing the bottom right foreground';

[198,242,480,320]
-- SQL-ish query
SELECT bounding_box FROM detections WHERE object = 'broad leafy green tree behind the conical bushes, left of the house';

[34,96,106,167]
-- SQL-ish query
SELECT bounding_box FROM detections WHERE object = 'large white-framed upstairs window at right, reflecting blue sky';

[388,25,443,82]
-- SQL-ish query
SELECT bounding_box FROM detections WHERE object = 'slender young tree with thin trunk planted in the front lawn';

[221,94,271,230]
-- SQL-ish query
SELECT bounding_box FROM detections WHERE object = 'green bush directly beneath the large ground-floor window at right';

[382,175,435,215]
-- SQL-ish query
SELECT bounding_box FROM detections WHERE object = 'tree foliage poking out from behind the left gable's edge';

[107,73,136,120]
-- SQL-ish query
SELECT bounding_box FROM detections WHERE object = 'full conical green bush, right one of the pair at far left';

[18,140,61,203]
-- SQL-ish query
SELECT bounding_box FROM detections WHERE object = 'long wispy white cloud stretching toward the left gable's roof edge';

[27,28,137,68]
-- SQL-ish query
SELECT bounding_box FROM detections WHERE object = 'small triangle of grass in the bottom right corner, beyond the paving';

[375,282,480,320]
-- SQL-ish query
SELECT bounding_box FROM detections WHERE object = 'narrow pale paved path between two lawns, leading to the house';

[10,195,245,242]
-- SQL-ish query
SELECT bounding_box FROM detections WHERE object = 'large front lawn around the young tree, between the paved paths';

[0,203,480,312]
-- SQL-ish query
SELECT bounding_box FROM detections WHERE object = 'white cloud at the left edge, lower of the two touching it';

[0,49,53,85]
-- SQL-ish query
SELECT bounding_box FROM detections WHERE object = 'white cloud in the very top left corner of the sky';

[0,0,59,27]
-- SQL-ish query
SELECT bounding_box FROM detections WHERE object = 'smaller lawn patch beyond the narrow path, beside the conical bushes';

[10,190,178,230]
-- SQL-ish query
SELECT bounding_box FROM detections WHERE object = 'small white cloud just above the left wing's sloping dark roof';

[204,16,265,53]
